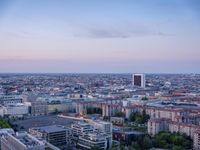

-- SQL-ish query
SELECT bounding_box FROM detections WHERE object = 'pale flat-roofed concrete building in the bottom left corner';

[1,133,45,150]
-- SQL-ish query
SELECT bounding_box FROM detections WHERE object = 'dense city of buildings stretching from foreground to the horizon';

[0,73,200,150]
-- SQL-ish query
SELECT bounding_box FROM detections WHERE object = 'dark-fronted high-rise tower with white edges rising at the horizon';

[132,74,146,88]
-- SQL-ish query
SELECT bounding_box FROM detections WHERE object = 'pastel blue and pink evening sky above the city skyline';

[0,0,200,73]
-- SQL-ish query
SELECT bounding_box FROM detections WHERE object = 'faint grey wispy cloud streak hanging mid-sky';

[74,24,172,38]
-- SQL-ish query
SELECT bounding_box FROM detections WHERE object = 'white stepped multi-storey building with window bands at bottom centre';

[72,120,112,149]
